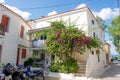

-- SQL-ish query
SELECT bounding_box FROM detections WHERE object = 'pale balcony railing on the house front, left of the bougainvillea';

[32,40,45,49]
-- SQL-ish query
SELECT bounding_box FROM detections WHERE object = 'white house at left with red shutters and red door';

[0,4,32,65]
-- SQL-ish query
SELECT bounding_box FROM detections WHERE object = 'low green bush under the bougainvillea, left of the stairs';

[50,59,78,73]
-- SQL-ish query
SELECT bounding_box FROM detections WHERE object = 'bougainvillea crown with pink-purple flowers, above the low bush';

[38,20,101,60]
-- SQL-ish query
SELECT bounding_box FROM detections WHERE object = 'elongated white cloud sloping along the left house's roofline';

[5,5,31,19]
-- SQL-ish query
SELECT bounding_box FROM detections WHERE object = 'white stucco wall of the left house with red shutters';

[0,5,30,63]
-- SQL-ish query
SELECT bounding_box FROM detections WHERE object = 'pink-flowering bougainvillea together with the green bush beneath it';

[38,20,101,73]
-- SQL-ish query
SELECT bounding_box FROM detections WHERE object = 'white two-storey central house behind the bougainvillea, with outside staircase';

[28,6,106,77]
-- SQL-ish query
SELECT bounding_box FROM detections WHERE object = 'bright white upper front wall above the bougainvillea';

[35,9,88,31]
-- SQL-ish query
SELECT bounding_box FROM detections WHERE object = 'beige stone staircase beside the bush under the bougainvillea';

[75,59,86,76]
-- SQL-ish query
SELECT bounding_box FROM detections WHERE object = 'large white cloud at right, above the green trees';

[93,8,118,20]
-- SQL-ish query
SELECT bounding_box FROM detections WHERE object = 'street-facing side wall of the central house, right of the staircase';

[87,11,106,77]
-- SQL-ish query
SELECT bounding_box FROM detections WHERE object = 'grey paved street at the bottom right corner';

[96,64,120,80]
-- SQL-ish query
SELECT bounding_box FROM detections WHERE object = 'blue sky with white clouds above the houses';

[0,0,120,55]
